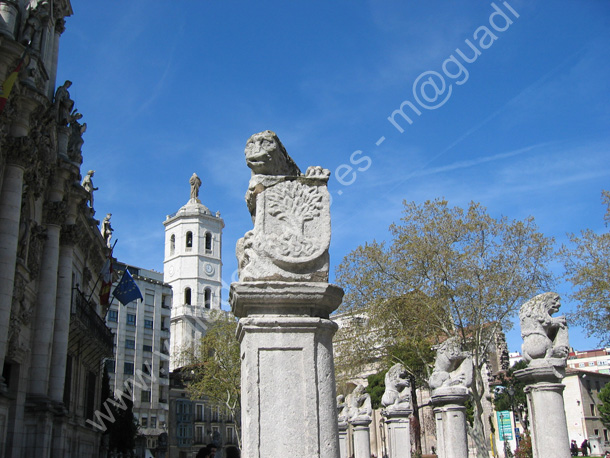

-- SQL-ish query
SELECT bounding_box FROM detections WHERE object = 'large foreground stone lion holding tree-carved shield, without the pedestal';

[236,130,330,282]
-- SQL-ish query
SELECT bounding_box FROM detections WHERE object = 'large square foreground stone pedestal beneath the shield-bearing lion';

[230,282,342,458]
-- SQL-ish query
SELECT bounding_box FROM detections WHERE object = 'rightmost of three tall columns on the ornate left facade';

[49,225,78,402]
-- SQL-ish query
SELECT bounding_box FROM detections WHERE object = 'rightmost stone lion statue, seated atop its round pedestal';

[519,292,570,366]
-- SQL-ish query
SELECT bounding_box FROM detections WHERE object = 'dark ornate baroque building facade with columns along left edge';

[0,0,113,458]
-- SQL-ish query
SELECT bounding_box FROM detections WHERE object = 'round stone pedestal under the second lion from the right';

[431,386,468,458]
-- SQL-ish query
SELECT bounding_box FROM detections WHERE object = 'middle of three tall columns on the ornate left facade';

[29,202,65,397]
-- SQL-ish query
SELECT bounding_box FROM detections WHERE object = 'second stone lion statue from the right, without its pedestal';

[428,336,473,390]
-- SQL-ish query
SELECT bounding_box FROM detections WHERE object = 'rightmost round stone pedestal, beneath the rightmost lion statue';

[515,366,570,458]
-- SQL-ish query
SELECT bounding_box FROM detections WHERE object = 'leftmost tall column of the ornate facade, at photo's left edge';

[0,163,25,382]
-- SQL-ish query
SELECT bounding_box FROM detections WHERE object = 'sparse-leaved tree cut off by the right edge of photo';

[559,191,610,345]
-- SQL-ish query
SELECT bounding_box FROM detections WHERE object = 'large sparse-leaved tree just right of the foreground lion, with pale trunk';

[337,200,553,457]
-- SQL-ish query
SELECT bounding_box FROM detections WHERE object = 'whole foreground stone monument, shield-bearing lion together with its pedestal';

[229,131,342,458]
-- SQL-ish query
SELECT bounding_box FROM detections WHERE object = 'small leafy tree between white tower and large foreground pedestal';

[182,310,241,448]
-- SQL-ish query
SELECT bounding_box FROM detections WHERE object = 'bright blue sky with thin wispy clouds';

[57,0,610,350]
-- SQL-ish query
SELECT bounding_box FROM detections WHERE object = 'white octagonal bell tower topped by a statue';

[163,174,224,370]
